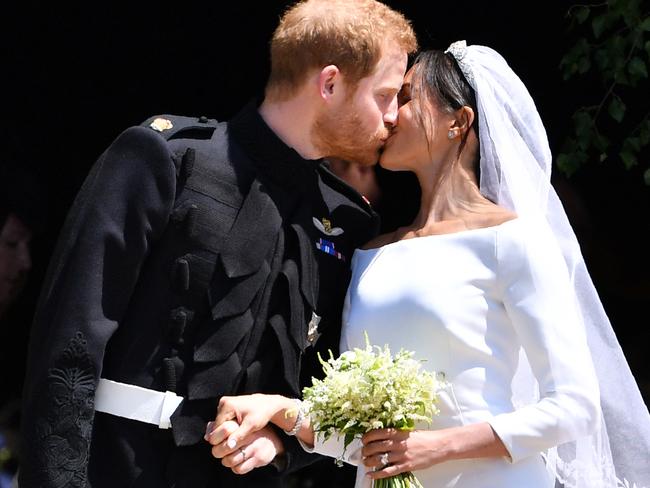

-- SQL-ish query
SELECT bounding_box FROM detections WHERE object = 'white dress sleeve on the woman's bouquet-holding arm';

[490,222,600,462]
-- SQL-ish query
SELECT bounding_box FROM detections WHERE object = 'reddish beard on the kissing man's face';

[312,110,390,166]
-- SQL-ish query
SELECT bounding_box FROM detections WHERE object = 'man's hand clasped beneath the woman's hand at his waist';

[205,420,284,474]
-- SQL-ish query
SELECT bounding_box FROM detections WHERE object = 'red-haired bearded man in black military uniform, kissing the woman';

[19,0,416,488]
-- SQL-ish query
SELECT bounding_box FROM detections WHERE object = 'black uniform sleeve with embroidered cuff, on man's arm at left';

[20,127,176,488]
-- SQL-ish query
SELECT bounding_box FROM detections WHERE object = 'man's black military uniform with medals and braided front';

[20,103,378,488]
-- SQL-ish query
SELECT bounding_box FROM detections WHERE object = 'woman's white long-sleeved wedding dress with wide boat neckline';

[306,218,599,488]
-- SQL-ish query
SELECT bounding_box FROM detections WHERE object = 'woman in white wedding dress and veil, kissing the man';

[206,41,650,488]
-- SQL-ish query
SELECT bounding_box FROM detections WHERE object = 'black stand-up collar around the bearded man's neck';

[228,100,323,186]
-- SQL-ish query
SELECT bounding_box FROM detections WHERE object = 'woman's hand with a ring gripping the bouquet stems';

[361,429,445,479]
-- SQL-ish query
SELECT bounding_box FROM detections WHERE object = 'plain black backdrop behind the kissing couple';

[0,0,650,486]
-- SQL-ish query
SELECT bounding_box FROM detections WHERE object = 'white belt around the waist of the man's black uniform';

[95,378,183,429]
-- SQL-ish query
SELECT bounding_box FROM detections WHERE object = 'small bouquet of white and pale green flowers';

[303,335,445,488]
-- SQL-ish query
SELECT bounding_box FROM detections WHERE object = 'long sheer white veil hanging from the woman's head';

[445,41,650,488]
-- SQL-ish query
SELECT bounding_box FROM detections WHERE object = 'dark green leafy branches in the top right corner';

[556,0,650,186]
